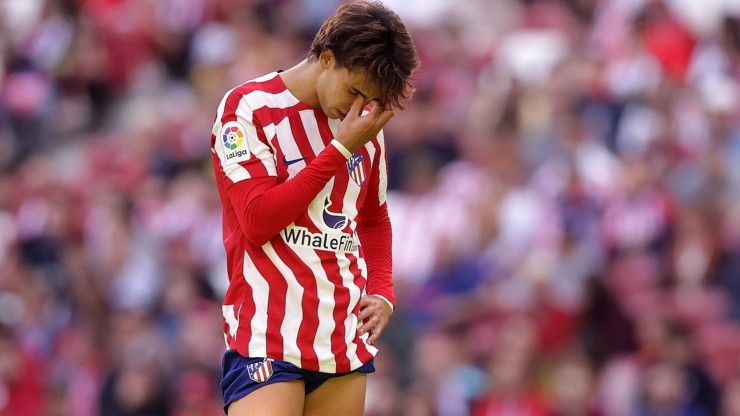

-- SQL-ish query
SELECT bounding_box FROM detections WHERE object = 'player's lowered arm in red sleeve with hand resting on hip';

[357,134,396,344]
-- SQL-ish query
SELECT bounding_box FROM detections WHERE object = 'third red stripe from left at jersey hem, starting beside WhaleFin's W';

[272,238,319,371]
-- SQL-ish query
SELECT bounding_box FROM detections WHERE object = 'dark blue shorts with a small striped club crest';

[221,350,375,412]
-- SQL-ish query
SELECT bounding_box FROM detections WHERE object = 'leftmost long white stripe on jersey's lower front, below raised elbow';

[243,252,270,357]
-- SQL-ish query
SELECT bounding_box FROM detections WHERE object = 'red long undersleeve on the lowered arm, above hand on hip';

[357,208,396,304]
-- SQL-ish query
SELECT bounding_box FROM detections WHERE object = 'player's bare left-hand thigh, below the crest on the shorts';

[228,380,306,416]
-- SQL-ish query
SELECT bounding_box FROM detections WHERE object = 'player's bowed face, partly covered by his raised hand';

[316,51,380,119]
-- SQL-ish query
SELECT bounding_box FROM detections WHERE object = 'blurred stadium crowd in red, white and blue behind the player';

[0,0,740,416]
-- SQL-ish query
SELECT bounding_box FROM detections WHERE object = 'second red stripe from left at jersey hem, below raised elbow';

[249,249,288,360]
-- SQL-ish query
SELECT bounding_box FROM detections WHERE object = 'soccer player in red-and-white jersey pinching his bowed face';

[211,2,418,416]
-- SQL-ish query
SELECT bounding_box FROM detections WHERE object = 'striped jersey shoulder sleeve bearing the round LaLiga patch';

[212,89,277,188]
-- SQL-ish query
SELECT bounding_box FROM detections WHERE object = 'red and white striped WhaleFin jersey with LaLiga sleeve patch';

[211,73,387,373]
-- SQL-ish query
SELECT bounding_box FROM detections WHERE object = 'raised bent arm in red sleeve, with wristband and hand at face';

[227,96,392,246]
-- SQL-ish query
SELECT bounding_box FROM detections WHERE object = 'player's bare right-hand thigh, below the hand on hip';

[303,373,367,416]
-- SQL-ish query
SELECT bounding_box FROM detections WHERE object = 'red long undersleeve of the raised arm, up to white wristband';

[228,141,347,246]
